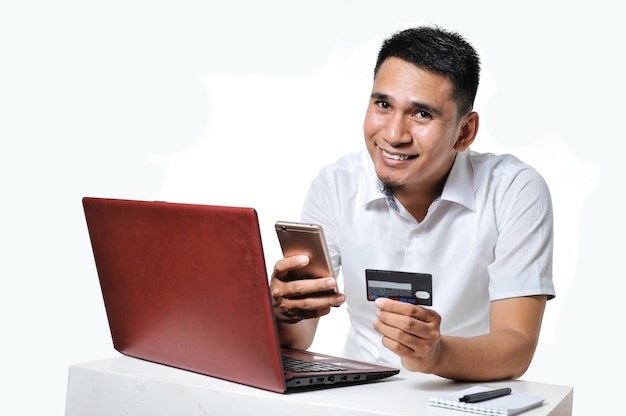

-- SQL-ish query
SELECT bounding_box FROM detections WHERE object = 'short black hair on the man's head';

[374,26,480,117]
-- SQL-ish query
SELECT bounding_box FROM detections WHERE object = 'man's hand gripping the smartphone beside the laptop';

[270,256,345,324]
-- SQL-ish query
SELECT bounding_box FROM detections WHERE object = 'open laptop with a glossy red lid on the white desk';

[82,197,399,393]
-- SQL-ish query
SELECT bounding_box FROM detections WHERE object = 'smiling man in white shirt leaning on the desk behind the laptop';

[271,27,555,381]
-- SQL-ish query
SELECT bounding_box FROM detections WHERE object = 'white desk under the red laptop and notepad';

[65,356,573,416]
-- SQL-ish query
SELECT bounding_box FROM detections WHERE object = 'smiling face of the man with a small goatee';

[363,58,469,192]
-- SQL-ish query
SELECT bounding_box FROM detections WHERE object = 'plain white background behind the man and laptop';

[0,0,626,415]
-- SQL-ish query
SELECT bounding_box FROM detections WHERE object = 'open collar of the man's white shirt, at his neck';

[362,150,476,211]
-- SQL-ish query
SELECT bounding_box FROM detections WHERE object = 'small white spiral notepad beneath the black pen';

[428,386,545,416]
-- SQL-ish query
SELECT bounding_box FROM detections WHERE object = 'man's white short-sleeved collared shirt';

[301,149,555,365]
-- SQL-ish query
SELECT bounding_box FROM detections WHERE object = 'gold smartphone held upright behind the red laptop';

[275,221,336,286]
